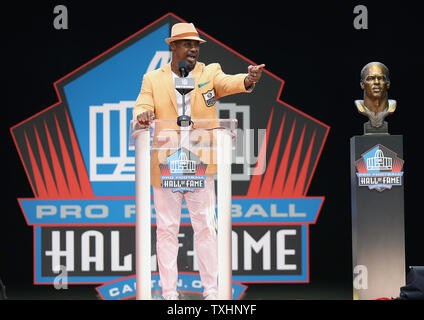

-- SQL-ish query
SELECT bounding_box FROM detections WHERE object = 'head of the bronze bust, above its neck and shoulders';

[361,63,390,99]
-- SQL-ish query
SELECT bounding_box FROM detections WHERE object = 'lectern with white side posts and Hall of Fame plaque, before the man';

[130,119,237,300]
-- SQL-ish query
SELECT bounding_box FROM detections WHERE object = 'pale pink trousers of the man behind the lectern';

[153,176,218,298]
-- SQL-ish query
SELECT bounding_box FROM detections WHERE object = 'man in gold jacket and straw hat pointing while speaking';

[133,23,265,300]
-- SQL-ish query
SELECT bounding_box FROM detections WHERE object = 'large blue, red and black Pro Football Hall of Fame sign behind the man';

[11,13,329,299]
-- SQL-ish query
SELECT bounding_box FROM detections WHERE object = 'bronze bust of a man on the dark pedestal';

[355,62,396,134]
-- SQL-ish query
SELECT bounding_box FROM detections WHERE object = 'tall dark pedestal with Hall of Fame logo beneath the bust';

[350,134,405,300]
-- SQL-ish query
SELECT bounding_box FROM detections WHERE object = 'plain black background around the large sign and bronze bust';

[4,0,424,299]
